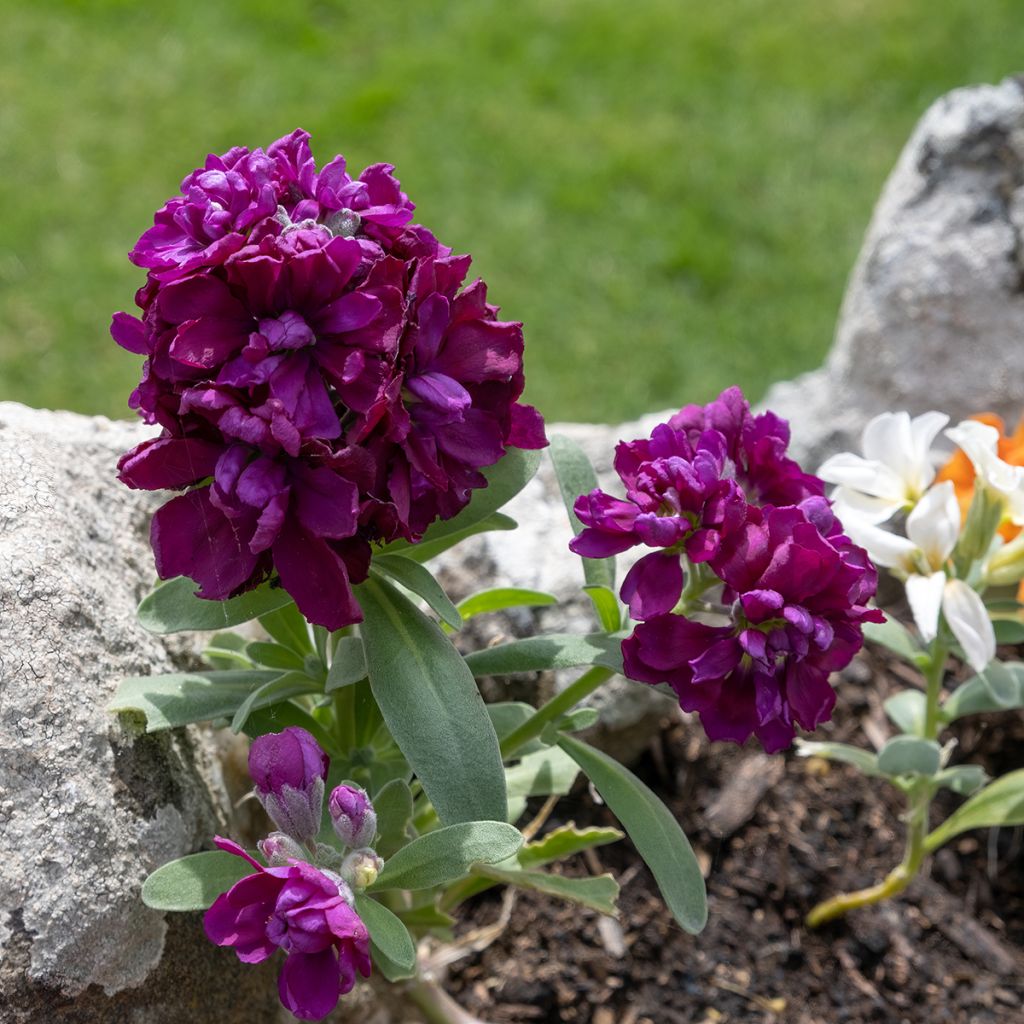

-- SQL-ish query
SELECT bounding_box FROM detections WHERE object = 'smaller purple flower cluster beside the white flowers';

[570,388,881,752]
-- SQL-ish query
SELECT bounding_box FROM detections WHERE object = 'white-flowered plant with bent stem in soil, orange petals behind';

[801,413,1024,925]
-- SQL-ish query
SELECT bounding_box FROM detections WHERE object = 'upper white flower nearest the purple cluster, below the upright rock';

[818,413,949,523]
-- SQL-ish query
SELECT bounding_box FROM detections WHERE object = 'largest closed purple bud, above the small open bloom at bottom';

[249,725,331,843]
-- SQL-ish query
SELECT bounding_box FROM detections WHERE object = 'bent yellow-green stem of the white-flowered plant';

[807,638,949,928]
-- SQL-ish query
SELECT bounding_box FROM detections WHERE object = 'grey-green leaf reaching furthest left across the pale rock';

[108,670,281,732]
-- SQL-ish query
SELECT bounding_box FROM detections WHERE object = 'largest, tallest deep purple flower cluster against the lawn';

[111,130,547,629]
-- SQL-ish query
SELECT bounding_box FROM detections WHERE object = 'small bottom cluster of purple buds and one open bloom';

[204,726,383,1021]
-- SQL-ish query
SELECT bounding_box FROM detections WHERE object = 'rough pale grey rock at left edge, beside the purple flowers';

[0,402,292,1024]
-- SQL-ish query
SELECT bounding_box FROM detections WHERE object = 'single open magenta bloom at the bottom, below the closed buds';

[203,836,371,1021]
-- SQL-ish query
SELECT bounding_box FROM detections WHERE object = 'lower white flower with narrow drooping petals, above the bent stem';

[845,480,995,672]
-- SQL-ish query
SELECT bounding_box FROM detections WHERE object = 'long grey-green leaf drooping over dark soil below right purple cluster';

[558,736,708,935]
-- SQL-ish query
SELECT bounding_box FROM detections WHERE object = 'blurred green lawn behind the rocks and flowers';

[0,0,1024,421]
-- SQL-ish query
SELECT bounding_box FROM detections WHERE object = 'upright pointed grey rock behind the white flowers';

[764,79,1024,468]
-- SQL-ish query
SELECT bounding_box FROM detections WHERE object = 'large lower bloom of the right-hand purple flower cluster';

[623,498,882,753]
